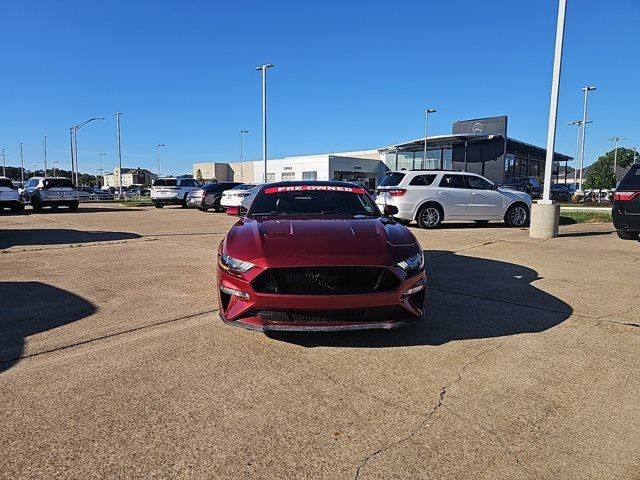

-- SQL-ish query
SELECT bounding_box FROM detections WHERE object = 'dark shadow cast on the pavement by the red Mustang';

[269,250,573,348]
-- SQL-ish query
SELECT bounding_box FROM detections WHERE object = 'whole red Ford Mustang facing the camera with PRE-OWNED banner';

[218,182,426,331]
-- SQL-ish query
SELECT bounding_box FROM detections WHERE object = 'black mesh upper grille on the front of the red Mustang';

[253,267,400,295]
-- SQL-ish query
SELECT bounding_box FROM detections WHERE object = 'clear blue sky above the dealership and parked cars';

[0,0,640,174]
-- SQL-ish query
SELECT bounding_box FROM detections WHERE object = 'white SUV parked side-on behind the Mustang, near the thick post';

[376,170,531,228]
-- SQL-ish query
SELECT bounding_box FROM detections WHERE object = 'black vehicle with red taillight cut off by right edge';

[611,164,640,240]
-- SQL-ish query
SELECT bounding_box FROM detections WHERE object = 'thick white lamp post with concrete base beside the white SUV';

[529,0,564,238]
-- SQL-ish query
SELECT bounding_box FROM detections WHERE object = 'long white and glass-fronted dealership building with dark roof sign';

[193,116,572,188]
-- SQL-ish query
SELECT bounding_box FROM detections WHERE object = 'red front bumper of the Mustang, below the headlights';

[218,268,426,331]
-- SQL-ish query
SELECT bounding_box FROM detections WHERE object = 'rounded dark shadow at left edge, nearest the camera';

[0,282,96,373]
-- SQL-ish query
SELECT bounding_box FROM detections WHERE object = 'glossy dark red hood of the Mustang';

[222,217,421,267]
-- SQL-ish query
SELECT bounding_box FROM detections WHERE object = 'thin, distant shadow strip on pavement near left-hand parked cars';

[0,228,141,250]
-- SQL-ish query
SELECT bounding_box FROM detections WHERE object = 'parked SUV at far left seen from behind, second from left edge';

[22,177,79,212]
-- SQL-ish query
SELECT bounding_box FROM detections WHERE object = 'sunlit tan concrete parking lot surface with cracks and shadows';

[0,205,640,480]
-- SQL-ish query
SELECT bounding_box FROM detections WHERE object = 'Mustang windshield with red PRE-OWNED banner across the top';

[249,185,380,217]
